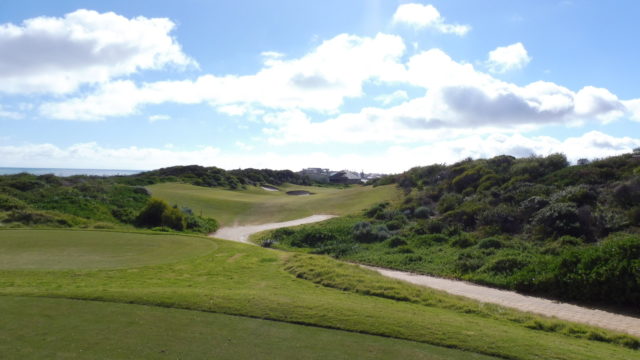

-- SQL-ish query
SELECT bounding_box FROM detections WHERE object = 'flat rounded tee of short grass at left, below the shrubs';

[0,230,215,270]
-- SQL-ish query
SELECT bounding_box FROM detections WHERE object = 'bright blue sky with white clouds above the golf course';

[0,0,640,173]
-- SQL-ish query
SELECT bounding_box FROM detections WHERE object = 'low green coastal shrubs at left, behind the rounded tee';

[0,173,218,233]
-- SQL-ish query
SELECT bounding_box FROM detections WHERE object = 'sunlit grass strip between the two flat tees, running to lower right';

[0,229,638,359]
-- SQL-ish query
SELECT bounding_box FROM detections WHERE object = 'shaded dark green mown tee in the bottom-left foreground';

[0,296,492,360]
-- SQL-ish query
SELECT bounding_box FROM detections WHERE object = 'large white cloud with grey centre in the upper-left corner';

[0,10,195,94]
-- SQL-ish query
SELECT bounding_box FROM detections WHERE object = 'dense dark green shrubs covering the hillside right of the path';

[259,154,640,310]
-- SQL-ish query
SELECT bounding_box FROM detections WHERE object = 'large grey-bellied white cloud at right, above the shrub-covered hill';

[264,49,635,144]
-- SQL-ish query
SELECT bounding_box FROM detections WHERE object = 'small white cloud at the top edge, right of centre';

[392,3,471,36]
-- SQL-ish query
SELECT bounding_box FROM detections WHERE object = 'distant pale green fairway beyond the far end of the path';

[147,183,400,226]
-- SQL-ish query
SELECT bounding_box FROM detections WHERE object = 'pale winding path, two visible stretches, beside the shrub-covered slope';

[209,215,640,337]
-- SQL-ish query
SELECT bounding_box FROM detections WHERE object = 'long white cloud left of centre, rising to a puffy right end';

[40,34,405,120]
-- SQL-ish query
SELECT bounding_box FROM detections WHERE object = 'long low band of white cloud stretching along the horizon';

[0,131,640,173]
